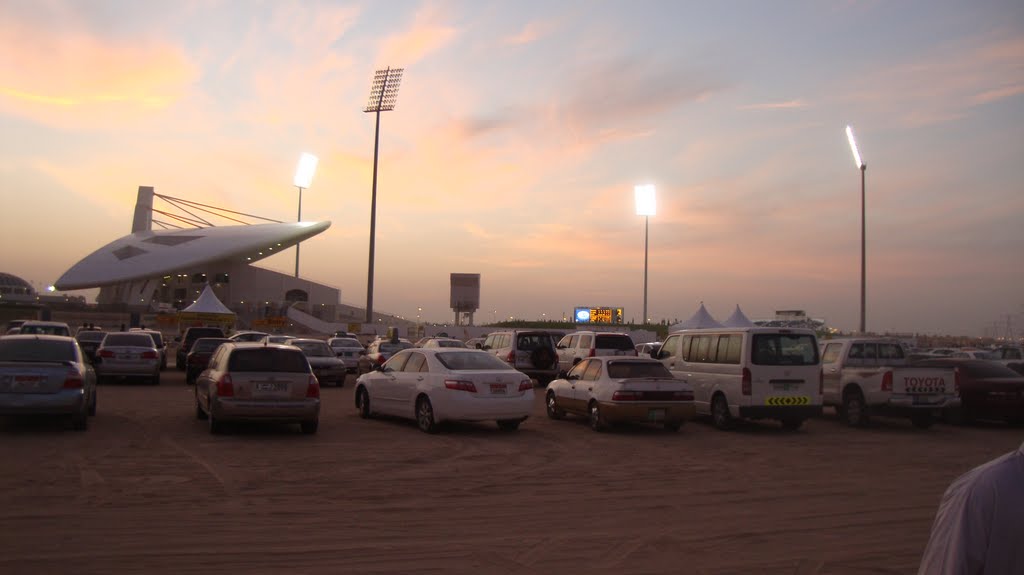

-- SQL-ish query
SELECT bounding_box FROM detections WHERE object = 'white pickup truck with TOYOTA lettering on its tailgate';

[821,338,959,429]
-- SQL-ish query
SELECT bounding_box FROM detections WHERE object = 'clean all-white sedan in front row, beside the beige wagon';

[355,348,534,433]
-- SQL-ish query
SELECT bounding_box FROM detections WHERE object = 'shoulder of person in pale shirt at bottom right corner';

[918,437,1024,575]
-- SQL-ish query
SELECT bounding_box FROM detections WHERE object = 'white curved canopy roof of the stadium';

[54,222,331,291]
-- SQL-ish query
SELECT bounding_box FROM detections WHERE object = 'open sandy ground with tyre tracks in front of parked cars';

[0,369,1024,574]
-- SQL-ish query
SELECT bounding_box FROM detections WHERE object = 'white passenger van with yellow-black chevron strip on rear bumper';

[654,327,822,430]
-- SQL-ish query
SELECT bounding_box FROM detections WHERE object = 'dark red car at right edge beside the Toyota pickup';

[914,357,1024,425]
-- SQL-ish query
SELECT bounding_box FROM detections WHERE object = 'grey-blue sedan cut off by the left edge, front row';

[0,334,96,431]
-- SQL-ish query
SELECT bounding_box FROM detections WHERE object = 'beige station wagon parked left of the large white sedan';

[195,342,321,434]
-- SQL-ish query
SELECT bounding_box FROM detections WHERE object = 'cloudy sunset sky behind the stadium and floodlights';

[0,0,1024,336]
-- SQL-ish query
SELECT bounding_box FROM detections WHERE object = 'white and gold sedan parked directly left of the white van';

[544,356,696,432]
